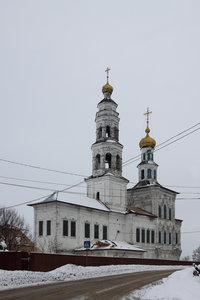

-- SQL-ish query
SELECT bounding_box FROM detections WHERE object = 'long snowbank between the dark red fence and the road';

[0,264,184,290]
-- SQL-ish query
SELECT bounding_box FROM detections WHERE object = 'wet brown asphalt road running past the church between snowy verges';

[0,270,175,300]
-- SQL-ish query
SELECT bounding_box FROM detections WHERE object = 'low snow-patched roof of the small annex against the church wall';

[75,240,146,252]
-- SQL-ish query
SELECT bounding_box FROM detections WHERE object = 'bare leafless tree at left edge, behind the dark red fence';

[0,208,34,251]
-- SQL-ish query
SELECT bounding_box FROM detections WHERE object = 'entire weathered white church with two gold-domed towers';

[30,72,182,260]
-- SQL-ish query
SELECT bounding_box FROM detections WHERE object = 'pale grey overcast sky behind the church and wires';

[0,0,200,256]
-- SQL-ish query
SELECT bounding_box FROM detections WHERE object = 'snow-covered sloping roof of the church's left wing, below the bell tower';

[30,193,110,211]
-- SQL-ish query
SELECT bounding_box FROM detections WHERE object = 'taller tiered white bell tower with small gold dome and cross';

[86,68,128,211]
